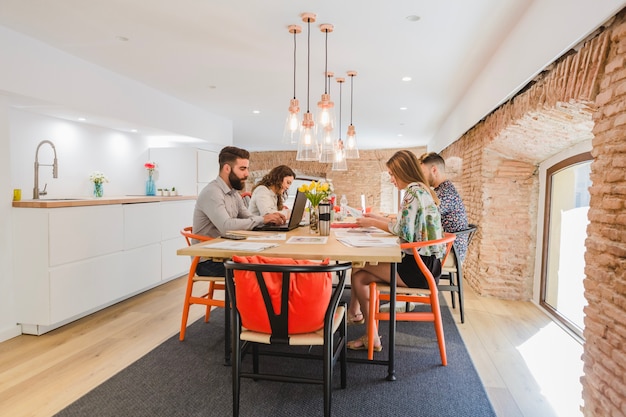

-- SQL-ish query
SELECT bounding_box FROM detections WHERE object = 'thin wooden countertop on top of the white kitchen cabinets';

[13,195,197,208]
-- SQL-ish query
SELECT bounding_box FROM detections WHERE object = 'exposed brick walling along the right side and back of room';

[251,7,626,417]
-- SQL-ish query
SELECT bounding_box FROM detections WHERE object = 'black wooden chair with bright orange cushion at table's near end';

[224,256,352,417]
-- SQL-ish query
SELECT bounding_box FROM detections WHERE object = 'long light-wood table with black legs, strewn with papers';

[176,227,402,381]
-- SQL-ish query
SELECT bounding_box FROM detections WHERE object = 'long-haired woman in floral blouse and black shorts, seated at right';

[348,150,445,352]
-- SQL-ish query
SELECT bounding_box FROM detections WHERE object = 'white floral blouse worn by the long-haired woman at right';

[389,182,445,259]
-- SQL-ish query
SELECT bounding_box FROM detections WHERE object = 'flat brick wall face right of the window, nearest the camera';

[582,11,626,416]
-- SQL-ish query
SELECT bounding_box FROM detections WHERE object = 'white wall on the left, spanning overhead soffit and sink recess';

[0,26,232,341]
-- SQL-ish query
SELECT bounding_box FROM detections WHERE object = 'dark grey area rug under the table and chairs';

[56,296,495,417]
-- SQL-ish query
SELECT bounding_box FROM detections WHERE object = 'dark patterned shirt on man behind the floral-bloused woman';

[435,180,469,262]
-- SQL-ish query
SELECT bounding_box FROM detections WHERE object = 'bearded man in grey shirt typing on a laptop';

[193,146,286,276]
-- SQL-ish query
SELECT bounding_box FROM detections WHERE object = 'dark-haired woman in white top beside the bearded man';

[248,165,296,217]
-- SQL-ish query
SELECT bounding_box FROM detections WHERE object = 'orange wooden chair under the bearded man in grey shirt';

[179,226,226,341]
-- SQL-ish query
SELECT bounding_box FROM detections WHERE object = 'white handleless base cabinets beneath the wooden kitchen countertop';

[13,200,195,334]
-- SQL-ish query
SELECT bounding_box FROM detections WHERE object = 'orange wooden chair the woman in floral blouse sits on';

[367,233,456,366]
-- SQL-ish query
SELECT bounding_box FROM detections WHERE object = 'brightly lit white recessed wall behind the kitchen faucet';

[9,109,157,199]
